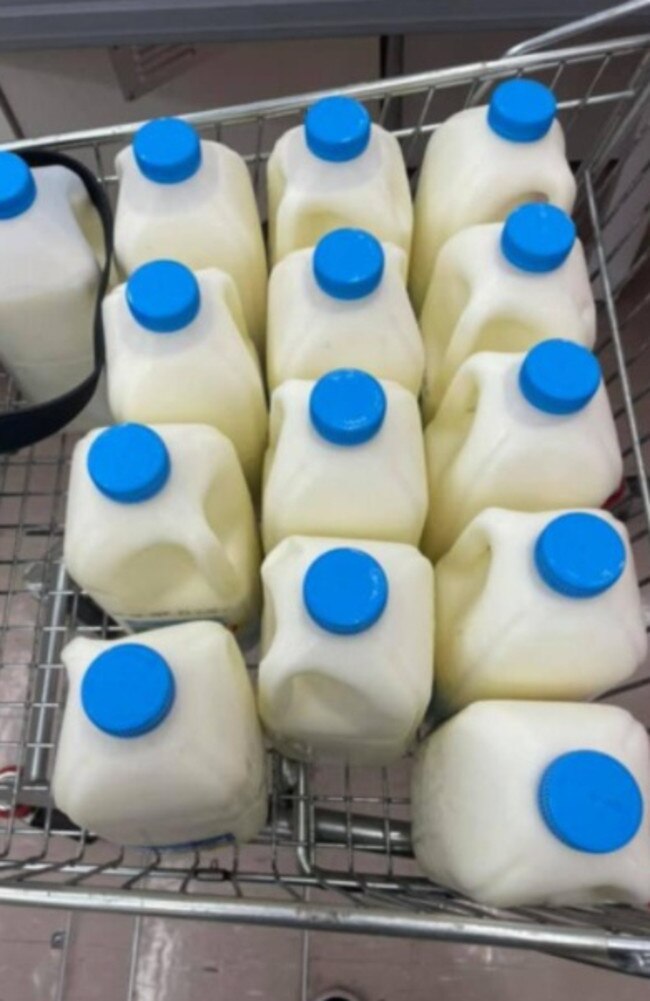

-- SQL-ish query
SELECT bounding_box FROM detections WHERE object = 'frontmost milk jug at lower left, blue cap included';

[52,622,267,848]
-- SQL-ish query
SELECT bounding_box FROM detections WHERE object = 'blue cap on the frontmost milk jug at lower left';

[81,643,175,737]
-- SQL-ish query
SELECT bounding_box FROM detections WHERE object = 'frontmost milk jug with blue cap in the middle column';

[258,536,434,765]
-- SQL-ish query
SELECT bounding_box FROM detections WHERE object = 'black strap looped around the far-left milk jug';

[0,149,113,452]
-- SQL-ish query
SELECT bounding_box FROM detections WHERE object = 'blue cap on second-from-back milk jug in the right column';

[501,201,576,274]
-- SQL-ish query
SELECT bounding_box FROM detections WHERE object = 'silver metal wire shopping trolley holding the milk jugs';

[0,2,650,977]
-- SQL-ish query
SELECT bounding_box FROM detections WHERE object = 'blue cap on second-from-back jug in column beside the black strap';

[126,260,201,333]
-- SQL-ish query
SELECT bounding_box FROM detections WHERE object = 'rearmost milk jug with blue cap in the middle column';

[266,96,413,262]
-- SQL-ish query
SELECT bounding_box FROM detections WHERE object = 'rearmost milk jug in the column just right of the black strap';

[115,118,266,348]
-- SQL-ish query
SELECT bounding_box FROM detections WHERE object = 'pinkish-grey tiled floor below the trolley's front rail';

[0,908,648,1001]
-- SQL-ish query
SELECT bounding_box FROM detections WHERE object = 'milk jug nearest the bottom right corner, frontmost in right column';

[412,702,650,907]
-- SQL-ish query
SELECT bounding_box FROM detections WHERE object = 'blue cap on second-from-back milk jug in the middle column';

[313,229,384,299]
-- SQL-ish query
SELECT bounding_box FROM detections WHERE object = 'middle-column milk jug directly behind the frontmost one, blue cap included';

[262,368,427,553]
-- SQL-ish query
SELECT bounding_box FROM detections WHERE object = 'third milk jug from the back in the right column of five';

[423,340,623,560]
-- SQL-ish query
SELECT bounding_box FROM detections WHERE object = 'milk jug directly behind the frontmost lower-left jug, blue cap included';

[64,424,259,629]
